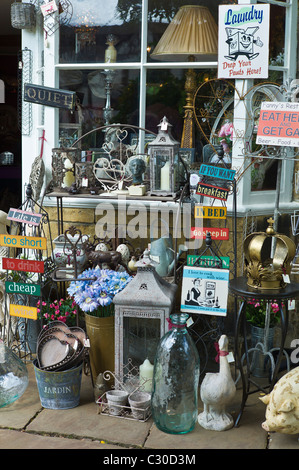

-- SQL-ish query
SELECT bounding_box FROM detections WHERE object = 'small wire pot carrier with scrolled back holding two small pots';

[96,358,151,422]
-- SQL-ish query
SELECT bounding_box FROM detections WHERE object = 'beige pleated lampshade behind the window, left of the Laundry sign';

[151,5,218,62]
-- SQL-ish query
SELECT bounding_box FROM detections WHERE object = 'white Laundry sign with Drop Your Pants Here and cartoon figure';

[218,4,270,79]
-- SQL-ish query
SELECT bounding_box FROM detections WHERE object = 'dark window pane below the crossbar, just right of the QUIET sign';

[59,70,139,149]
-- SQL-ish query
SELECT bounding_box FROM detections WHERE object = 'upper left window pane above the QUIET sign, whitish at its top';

[59,0,141,63]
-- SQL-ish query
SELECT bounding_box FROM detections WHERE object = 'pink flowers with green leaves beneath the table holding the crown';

[246,299,280,328]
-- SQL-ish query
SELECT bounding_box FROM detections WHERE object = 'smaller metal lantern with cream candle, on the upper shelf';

[148,116,183,196]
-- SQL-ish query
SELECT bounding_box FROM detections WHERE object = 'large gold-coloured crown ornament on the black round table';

[243,217,296,289]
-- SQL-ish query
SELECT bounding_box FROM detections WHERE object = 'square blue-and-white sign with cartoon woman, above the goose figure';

[181,266,229,316]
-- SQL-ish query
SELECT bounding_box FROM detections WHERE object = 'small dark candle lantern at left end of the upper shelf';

[52,147,80,191]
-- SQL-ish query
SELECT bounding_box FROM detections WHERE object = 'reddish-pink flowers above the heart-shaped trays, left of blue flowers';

[36,297,77,326]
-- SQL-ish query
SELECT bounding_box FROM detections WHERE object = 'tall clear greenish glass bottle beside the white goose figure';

[151,313,199,434]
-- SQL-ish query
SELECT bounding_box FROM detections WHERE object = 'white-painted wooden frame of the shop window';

[22,0,298,213]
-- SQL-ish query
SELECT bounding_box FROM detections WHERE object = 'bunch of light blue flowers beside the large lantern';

[67,266,132,317]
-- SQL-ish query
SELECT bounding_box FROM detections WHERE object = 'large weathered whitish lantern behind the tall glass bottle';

[113,251,177,382]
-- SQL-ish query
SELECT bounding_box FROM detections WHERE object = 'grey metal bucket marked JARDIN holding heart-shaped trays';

[33,360,83,410]
